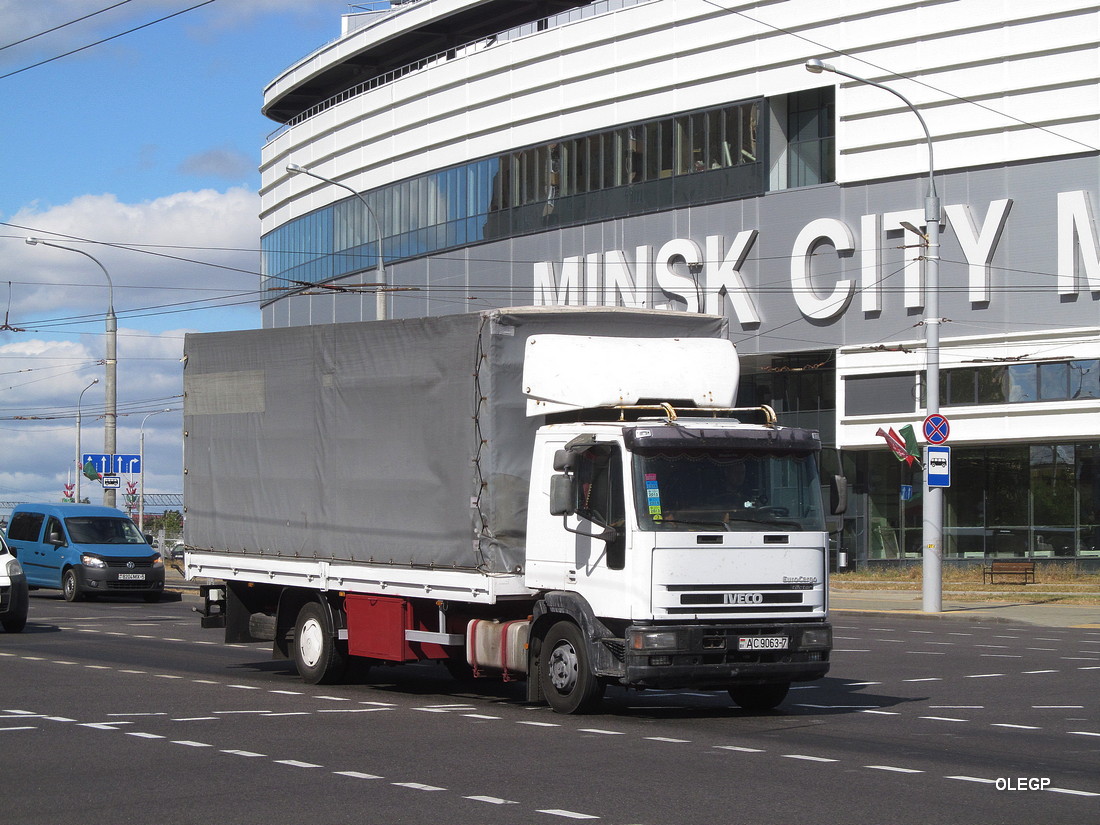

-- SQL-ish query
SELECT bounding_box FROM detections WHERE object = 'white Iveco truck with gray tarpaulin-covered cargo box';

[184,307,844,713]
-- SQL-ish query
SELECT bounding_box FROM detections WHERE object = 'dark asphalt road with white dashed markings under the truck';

[0,593,1100,825]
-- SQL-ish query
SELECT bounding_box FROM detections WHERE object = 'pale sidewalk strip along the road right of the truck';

[829,587,1100,629]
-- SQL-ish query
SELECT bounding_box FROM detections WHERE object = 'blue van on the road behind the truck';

[8,504,164,602]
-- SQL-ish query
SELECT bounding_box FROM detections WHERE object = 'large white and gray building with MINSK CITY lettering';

[261,0,1100,567]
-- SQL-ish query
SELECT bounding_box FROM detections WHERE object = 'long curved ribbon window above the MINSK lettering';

[261,100,765,300]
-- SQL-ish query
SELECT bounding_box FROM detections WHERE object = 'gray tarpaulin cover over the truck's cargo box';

[184,307,726,573]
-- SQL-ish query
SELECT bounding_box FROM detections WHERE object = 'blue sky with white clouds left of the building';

[0,0,380,516]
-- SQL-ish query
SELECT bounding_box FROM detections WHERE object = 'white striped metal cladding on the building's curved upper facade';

[262,0,1100,232]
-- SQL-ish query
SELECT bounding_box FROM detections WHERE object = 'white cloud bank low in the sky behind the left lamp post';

[0,188,260,502]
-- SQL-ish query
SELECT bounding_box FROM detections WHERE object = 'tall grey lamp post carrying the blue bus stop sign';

[805,58,944,613]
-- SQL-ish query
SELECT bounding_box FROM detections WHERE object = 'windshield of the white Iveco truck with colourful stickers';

[634,449,825,531]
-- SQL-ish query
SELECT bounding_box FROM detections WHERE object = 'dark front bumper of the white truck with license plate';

[620,623,833,690]
